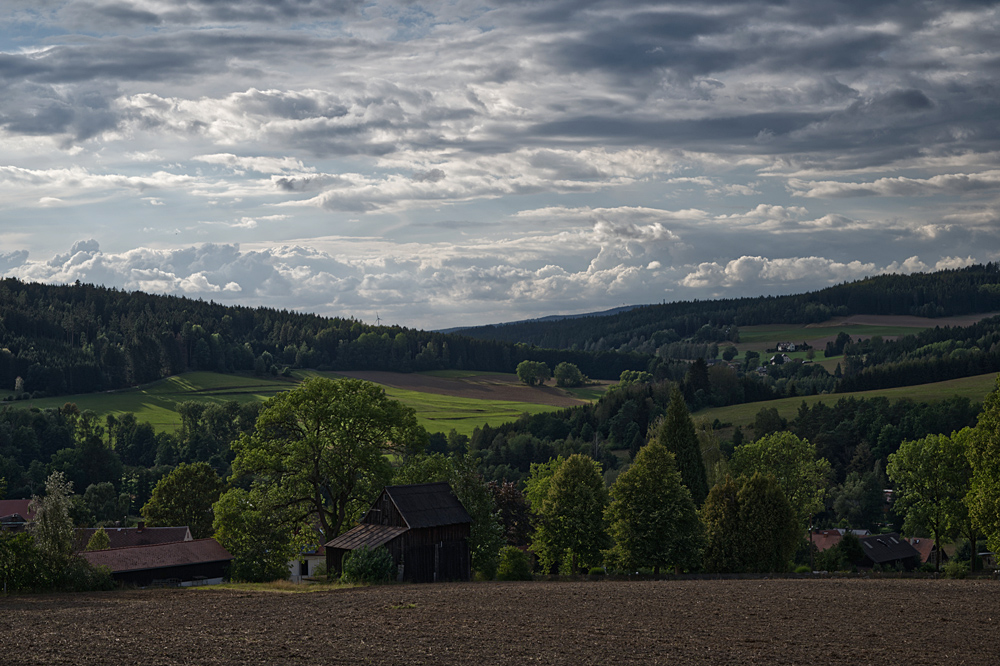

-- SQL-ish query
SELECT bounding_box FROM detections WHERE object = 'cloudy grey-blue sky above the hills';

[0,0,1000,329]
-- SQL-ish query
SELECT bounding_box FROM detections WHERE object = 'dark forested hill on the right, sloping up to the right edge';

[462,263,1000,351]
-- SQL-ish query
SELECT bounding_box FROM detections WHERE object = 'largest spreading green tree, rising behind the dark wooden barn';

[233,378,427,542]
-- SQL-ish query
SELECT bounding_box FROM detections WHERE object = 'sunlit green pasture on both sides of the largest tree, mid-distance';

[11,372,559,435]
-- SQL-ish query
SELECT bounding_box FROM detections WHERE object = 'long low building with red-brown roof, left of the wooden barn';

[80,539,233,586]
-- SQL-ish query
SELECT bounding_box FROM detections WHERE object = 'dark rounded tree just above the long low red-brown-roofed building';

[142,462,225,539]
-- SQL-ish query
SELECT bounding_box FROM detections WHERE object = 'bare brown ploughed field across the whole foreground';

[0,579,1000,666]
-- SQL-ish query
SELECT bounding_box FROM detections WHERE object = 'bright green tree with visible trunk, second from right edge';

[886,435,972,570]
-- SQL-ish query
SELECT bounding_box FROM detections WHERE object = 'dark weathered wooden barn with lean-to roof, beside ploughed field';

[326,483,472,583]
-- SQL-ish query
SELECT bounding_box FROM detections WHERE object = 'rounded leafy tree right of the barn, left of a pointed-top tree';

[531,453,608,572]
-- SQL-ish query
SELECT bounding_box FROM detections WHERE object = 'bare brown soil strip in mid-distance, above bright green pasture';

[337,370,586,407]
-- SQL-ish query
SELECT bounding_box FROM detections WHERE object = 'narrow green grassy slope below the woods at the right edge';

[693,373,997,426]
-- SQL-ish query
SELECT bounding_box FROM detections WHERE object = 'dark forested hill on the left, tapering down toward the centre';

[0,279,649,397]
